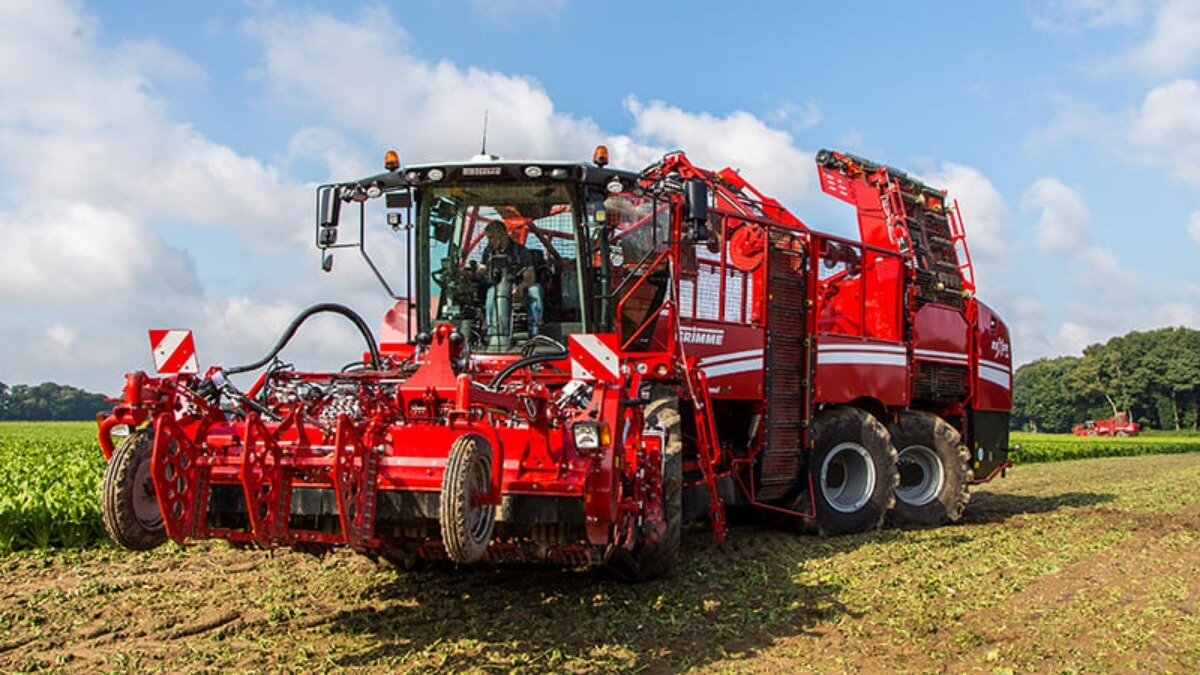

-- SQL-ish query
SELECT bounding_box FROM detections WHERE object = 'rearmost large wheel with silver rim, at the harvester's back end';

[888,411,971,526]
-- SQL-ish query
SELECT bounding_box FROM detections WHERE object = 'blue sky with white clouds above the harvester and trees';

[0,0,1200,392]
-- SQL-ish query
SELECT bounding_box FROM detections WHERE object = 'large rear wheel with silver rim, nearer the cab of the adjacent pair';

[809,407,896,534]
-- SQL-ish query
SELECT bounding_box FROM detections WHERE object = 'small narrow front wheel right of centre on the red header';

[439,434,496,565]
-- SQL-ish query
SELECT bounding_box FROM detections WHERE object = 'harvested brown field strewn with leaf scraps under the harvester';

[0,454,1200,673]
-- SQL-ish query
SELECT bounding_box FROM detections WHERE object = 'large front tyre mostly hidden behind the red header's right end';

[608,386,683,581]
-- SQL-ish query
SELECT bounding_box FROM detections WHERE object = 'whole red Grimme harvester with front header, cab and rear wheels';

[100,147,1012,579]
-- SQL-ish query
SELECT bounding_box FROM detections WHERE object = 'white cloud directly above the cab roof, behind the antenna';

[245,8,605,161]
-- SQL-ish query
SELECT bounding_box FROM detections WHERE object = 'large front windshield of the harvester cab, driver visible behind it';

[416,183,586,353]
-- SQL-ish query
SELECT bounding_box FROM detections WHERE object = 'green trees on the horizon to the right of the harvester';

[1013,328,1200,432]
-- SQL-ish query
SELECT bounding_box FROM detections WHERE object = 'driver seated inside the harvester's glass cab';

[479,220,545,338]
